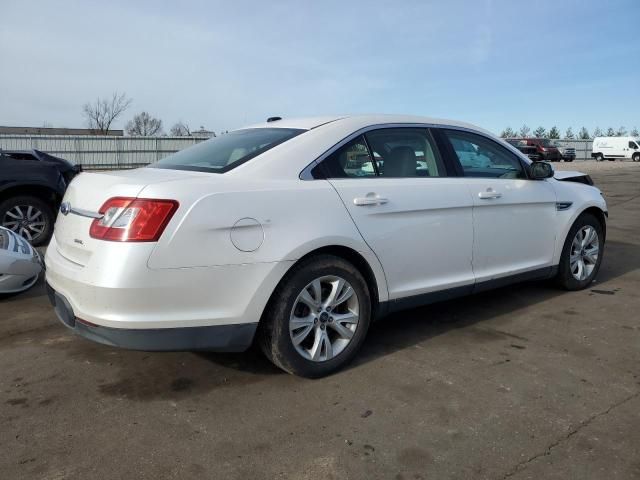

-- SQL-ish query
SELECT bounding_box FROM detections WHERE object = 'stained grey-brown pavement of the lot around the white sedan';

[0,162,640,480]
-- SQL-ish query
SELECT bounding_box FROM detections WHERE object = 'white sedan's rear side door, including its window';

[321,127,473,299]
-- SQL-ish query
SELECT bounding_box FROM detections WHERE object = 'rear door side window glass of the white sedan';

[321,128,446,178]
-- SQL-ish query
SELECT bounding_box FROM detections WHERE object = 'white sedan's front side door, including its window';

[436,129,556,283]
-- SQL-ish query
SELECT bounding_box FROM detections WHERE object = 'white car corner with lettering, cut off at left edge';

[0,227,42,294]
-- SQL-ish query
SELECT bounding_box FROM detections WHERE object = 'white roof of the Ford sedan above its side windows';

[244,114,493,136]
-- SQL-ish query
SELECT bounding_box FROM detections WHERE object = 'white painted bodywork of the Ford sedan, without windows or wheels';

[46,115,606,329]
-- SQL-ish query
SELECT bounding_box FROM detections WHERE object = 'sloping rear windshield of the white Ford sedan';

[149,128,305,173]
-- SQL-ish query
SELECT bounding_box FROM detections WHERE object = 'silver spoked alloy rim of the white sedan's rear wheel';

[289,275,360,362]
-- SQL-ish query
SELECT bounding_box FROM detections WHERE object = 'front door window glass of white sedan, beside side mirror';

[444,130,527,178]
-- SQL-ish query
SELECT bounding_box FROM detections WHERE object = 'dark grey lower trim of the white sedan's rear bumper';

[47,283,258,352]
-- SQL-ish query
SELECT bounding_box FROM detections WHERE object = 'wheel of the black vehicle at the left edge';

[0,195,55,247]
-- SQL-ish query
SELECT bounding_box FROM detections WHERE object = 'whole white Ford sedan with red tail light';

[46,115,607,377]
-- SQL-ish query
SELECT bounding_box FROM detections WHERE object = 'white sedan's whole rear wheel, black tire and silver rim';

[258,255,371,378]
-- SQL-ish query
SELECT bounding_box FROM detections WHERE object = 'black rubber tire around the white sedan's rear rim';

[264,255,371,378]
